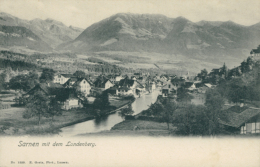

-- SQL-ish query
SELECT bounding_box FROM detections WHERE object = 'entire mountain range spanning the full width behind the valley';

[0,13,260,71]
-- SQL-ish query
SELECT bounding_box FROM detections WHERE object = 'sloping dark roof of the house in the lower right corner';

[219,108,260,128]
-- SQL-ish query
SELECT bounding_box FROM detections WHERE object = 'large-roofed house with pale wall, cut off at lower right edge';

[219,106,260,135]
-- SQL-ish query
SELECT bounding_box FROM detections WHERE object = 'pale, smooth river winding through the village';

[60,90,160,137]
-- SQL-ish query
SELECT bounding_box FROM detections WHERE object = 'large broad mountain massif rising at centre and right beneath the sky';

[58,13,260,56]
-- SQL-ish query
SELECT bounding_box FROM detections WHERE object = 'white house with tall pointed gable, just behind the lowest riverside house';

[63,77,91,96]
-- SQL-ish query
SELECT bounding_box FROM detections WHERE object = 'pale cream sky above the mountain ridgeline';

[0,0,260,29]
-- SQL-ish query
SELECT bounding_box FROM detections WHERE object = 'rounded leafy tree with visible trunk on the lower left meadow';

[23,91,50,126]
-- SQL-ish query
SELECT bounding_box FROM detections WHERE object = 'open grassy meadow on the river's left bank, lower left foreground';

[0,107,92,135]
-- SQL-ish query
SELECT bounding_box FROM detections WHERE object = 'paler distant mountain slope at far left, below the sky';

[0,12,83,51]
